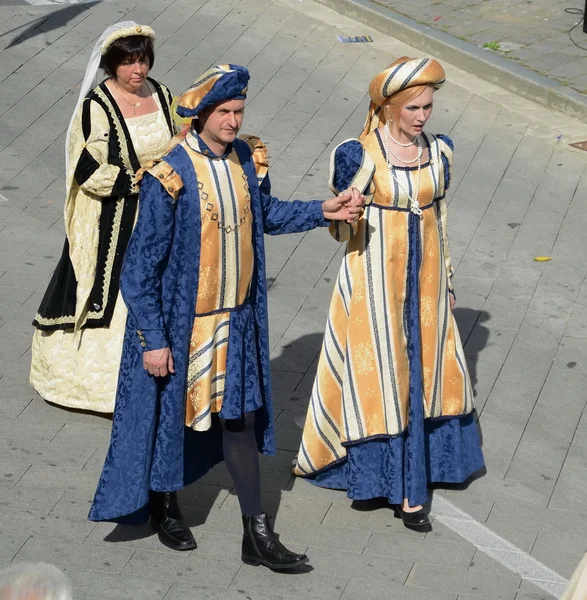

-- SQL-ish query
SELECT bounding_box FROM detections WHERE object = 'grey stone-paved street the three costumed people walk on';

[0,0,587,600]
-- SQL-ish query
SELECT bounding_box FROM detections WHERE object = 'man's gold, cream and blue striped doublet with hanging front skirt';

[184,134,254,431]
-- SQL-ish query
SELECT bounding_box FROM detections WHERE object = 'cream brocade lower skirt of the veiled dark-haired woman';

[30,292,127,413]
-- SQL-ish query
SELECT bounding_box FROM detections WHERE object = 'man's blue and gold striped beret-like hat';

[176,65,250,119]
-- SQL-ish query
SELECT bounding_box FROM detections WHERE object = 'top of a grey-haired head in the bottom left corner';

[0,563,73,600]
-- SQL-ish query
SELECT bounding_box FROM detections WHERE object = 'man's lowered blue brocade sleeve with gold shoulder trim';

[120,161,183,351]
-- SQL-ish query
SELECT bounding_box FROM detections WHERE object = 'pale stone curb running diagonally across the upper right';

[316,0,587,123]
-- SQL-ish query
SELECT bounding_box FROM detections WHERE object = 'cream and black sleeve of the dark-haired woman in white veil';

[74,98,135,198]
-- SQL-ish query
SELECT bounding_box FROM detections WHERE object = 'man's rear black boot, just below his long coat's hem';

[149,492,197,550]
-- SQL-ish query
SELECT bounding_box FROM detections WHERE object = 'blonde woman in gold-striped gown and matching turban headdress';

[294,57,484,530]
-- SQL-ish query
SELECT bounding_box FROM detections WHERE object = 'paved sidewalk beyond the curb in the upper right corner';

[375,0,587,94]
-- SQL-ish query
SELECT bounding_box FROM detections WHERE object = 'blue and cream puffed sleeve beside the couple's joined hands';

[328,139,375,242]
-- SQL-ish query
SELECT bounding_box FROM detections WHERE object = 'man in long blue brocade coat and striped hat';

[89,65,362,569]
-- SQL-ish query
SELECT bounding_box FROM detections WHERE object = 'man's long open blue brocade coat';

[89,140,328,524]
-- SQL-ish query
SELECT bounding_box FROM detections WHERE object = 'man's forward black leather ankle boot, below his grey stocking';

[242,514,308,571]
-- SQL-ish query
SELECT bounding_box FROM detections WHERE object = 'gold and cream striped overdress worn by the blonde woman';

[295,131,473,475]
